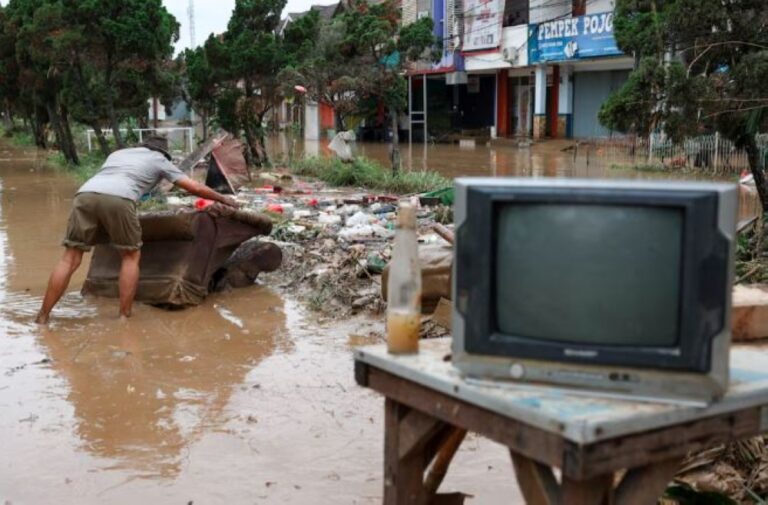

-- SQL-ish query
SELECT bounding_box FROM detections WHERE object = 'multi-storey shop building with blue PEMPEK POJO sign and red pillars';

[403,0,633,140]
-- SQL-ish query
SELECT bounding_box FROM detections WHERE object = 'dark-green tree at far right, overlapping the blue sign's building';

[599,0,768,210]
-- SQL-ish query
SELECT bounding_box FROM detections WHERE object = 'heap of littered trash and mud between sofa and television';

[231,173,449,316]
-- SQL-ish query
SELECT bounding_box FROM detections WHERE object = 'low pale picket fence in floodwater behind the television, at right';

[580,133,768,174]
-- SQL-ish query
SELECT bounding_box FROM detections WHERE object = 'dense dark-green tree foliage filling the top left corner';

[0,0,179,164]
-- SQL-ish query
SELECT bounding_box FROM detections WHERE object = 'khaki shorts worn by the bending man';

[62,193,142,251]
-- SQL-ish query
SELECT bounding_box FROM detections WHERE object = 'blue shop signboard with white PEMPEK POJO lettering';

[528,12,624,63]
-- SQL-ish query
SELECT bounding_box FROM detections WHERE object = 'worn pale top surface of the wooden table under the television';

[355,338,768,445]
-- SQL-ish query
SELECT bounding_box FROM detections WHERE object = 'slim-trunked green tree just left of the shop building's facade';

[342,0,439,171]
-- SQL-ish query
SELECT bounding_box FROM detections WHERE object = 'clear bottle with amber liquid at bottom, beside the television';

[387,204,421,354]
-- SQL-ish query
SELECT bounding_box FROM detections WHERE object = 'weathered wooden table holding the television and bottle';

[355,339,768,505]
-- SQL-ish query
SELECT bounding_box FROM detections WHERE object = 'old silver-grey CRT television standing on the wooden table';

[452,178,738,403]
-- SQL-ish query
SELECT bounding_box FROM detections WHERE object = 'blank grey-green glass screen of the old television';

[495,203,684,347]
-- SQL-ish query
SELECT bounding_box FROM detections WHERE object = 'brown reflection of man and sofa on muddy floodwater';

[40,288,290,478]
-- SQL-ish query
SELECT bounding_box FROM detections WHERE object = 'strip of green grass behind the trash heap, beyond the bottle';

[291,157,451,194]
